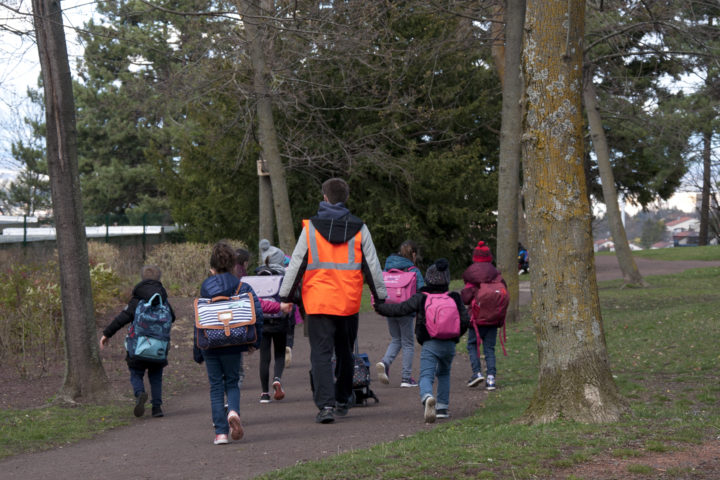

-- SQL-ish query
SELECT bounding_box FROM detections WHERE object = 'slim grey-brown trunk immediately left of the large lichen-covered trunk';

[497,0,525,322]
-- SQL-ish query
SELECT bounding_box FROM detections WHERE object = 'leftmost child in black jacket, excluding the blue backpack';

[100,265,175,417]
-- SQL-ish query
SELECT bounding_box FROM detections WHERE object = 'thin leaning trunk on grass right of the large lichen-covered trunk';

[583,72,647,287]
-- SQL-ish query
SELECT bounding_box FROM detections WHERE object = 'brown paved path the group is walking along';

[0,256,720,480]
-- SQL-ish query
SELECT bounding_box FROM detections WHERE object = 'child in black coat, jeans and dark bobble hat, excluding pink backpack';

[375,258,469,423]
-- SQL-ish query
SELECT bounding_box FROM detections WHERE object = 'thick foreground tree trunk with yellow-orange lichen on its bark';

[522,0,627,424]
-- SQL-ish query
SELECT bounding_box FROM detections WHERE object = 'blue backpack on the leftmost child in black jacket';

[125,293,172,363]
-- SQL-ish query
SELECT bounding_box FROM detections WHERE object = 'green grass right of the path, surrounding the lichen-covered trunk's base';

[261,264,720,479]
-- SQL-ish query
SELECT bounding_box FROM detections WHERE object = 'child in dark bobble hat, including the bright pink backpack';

[375,258,470,423]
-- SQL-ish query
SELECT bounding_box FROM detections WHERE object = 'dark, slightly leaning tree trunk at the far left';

[32,0,109,402]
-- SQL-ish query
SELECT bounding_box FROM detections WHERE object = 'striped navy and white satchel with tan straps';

[195,282,258,350]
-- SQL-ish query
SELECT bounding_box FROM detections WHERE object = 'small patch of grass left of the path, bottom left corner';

[0,405,132,458]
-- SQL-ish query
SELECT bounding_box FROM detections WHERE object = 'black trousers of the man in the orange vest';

[307,314,359,409]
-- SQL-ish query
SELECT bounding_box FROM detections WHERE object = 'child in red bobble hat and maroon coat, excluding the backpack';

[460,240,507,390]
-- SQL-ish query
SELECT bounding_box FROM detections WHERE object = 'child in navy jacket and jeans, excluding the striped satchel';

[193,242,263,445]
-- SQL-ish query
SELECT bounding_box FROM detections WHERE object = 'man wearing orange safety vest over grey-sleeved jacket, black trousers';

[280,178,387,423]
